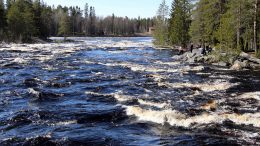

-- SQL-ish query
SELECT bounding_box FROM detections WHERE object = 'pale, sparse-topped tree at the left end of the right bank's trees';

[153,0,169,46]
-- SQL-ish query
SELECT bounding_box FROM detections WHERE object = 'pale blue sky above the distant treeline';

[43,0,172,18]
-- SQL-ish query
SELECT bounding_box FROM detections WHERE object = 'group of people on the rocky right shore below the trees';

[178,44,213,55]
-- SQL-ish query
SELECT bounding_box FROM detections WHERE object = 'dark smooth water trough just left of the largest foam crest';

[77,109,127,124]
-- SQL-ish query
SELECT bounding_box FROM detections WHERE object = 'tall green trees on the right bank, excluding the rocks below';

[155,0,260,55]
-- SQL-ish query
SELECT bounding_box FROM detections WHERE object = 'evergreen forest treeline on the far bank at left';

[0,0,155,42]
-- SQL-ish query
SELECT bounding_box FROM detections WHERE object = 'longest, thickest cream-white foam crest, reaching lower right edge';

[124,106,260,128]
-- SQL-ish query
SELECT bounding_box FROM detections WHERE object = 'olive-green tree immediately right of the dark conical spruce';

[190,0,229,46]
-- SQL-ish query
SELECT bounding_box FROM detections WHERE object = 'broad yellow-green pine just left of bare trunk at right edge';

[216,0,253,51]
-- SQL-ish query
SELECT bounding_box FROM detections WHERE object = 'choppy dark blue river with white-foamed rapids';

[0,38,260,146]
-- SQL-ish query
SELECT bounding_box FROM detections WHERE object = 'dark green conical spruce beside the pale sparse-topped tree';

[170,0,190,47]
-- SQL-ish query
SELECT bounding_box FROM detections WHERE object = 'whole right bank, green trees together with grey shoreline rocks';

[153,0,260,70]
